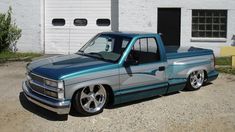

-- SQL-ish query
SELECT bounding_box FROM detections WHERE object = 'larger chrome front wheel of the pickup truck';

[79,85,107,113]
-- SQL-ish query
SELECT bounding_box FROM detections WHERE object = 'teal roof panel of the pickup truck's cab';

[102,31,157,37]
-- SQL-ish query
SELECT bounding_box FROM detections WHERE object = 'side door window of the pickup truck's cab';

[128,38,160,64]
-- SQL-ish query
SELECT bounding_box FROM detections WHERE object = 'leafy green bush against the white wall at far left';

[0,7,21,52]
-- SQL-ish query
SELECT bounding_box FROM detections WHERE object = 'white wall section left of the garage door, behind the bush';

[0,0,43,52]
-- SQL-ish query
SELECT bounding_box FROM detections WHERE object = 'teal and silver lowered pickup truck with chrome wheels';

[22,32,218,115]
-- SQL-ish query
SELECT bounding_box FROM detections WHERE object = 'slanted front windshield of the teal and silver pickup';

[79,34,131,62]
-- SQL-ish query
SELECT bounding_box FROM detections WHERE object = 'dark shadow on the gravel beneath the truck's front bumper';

[19,92,68,121]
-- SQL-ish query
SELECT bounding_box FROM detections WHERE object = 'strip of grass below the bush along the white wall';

[0,51,42,63]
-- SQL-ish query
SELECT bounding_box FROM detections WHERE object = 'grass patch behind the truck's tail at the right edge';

[215,57,235,75]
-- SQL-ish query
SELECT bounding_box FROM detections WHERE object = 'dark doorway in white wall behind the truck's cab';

[158,8,181,46]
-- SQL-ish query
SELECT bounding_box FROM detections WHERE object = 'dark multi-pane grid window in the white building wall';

[192,10,227,38]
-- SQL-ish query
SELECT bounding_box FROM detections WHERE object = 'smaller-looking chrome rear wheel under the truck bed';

[189,70,204,89]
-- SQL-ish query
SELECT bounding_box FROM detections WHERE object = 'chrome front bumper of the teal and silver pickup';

[22,82,71,114]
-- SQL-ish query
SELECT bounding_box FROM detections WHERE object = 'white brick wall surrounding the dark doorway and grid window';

[119,0,235,55]
